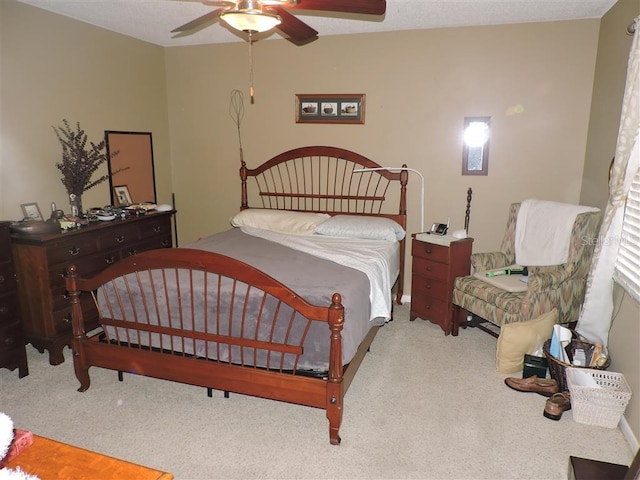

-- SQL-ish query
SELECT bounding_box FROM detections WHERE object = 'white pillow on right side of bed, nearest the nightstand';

[316,215,405,242]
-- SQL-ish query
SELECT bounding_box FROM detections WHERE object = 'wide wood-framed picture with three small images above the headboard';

[296,93,365,124]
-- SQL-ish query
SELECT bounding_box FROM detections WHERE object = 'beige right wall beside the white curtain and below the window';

[580,0,640,446]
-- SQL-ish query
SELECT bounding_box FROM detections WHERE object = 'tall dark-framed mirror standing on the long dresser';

[104,130,157,206]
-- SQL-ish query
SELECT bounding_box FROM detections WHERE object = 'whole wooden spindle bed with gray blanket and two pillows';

[66,146,408,445]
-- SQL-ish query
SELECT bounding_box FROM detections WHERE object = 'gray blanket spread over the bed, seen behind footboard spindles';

[98,228,383,372]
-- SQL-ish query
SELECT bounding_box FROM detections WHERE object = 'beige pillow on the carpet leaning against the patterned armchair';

[496,308,558,373]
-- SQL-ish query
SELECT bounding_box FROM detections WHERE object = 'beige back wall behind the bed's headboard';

[166,20,599,251]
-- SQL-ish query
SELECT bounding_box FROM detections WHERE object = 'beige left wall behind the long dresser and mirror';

[0,0,172,220]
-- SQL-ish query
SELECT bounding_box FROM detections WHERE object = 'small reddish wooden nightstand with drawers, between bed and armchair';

[409,235,473,335]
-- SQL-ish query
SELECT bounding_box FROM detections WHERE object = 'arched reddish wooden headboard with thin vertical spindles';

[240,146,409,304]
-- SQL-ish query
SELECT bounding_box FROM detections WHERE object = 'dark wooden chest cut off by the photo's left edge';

[0,222,29,378]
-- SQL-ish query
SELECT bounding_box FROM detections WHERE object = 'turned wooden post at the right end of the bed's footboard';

[326,293,344,445]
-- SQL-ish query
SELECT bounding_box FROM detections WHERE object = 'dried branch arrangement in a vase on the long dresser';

[53,119,124,217]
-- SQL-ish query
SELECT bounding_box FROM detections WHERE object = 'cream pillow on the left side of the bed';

[231,208,330,235]
